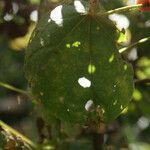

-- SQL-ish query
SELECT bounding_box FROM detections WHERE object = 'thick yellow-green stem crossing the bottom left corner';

[0,120,37,149]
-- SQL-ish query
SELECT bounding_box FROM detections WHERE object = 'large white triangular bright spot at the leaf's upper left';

[50,5,63,27]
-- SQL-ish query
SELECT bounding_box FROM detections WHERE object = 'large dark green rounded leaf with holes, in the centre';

[25,1,133,123]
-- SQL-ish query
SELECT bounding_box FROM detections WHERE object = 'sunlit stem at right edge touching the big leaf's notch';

[119,37,150,53]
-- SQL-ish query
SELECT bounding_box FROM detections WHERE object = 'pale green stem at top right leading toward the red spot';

[97,4,144,16]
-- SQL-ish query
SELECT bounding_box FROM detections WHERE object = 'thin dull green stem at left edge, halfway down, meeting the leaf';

[0,82,29,97]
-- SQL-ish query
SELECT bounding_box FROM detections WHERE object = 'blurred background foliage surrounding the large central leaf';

[0,0,150,150]
